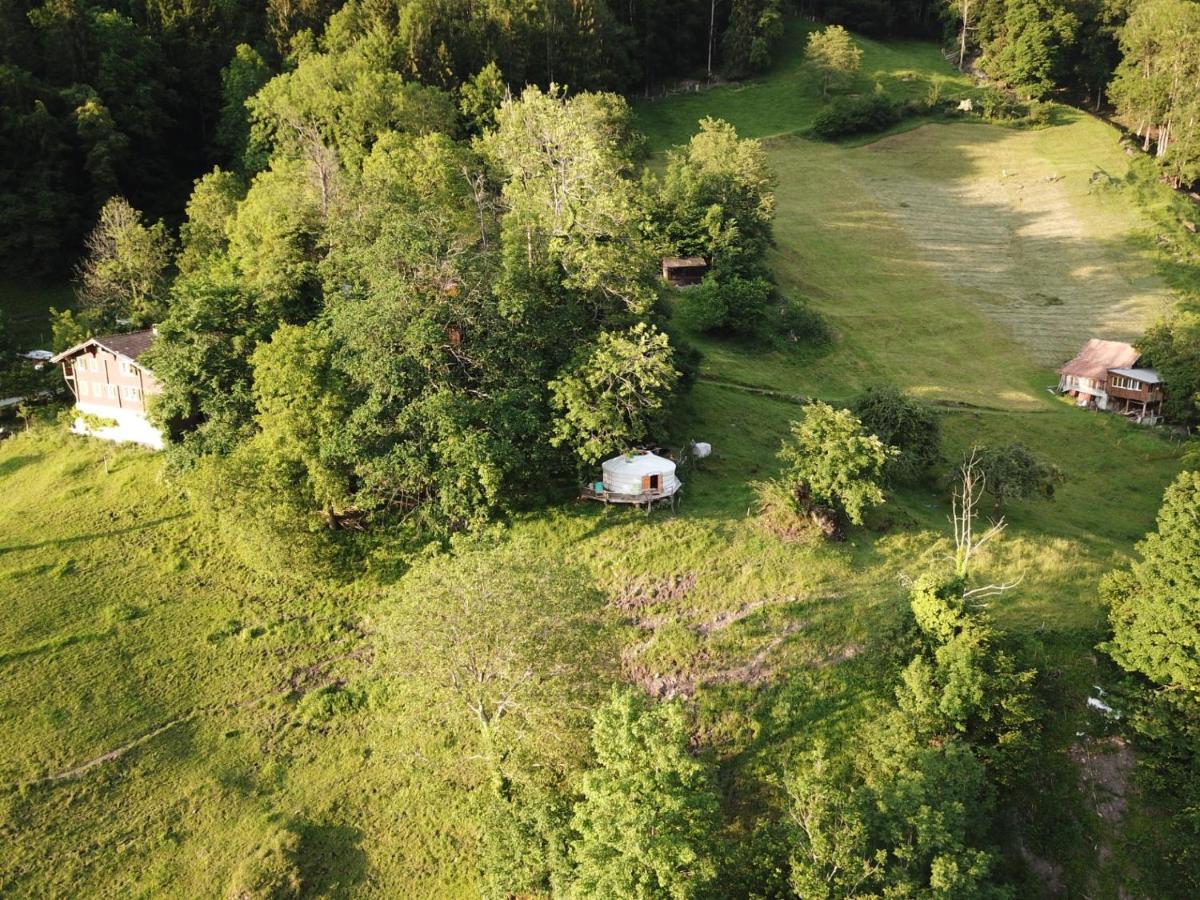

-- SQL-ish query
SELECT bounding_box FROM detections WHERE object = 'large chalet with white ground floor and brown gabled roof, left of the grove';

[50,329,163,450]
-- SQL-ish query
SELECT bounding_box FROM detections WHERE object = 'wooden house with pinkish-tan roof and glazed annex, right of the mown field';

[1058,338,1163,425]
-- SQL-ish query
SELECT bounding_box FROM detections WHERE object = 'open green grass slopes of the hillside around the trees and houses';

[0,15,1195,898]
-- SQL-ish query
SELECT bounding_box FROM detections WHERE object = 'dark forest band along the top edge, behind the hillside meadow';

[0,0,1200,276]
